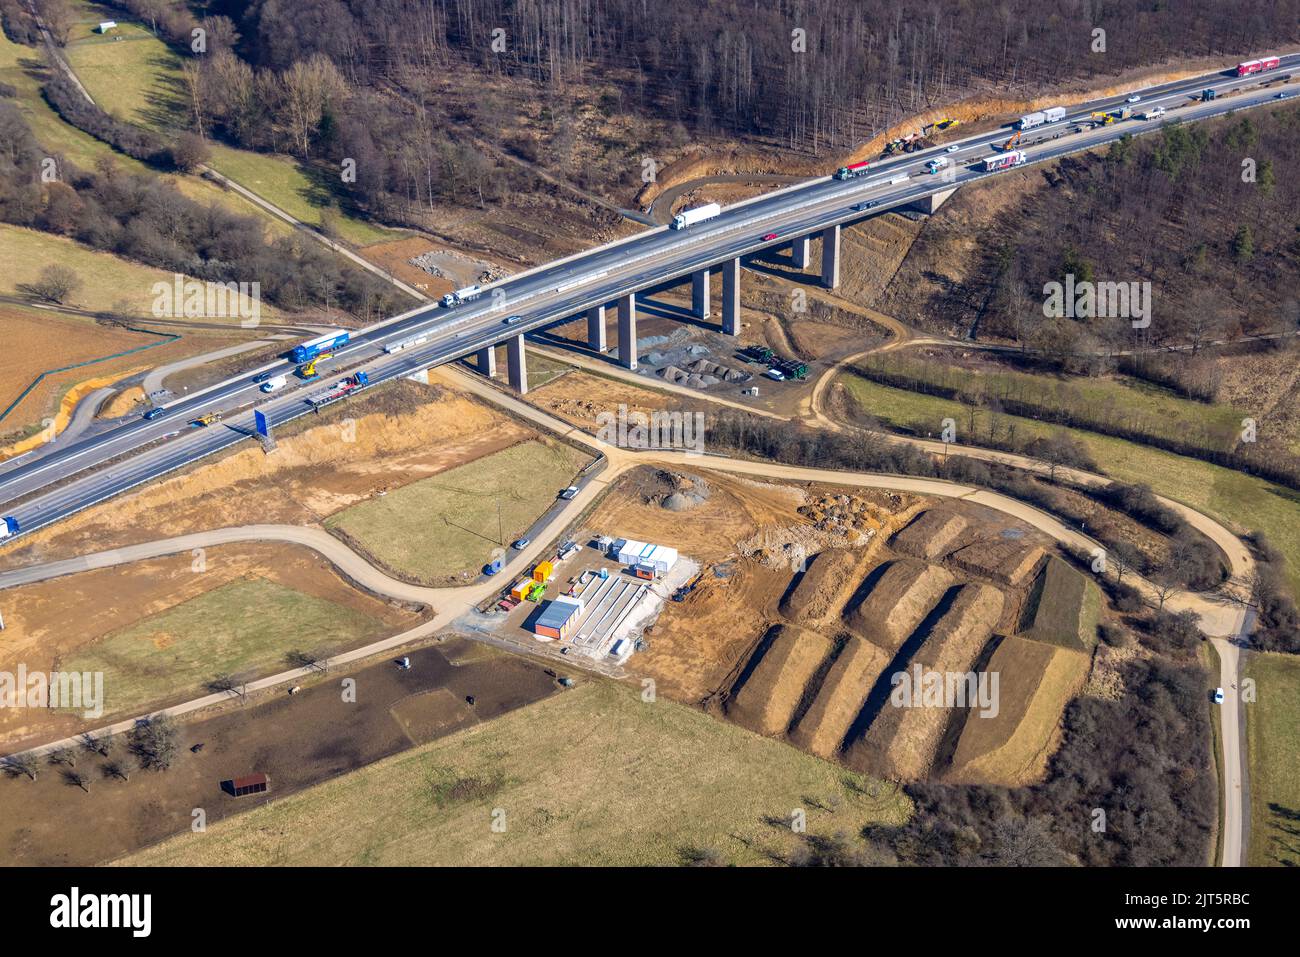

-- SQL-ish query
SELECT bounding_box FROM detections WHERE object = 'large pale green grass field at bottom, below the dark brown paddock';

[122,680,909,866]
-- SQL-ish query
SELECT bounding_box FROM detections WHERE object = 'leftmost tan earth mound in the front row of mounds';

[727,624,832,735]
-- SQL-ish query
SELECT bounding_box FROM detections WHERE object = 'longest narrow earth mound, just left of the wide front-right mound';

[845,585,1002,781]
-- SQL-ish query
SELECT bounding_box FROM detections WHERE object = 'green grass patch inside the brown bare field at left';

[59,579,385,714]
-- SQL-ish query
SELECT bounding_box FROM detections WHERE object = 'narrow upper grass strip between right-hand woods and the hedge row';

[863,354,1245,450]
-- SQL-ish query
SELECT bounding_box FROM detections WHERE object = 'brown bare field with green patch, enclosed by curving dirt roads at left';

[0,544,420,749]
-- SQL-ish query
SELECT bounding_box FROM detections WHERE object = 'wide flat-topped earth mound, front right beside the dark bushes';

[944,638,1088,788]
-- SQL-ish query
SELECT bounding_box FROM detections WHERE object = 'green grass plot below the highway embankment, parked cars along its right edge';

[325,441,586,581]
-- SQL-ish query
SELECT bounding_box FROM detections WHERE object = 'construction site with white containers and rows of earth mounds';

[483,467,1101,785]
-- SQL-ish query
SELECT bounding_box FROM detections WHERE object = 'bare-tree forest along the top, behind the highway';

[78,0,1300,217]
